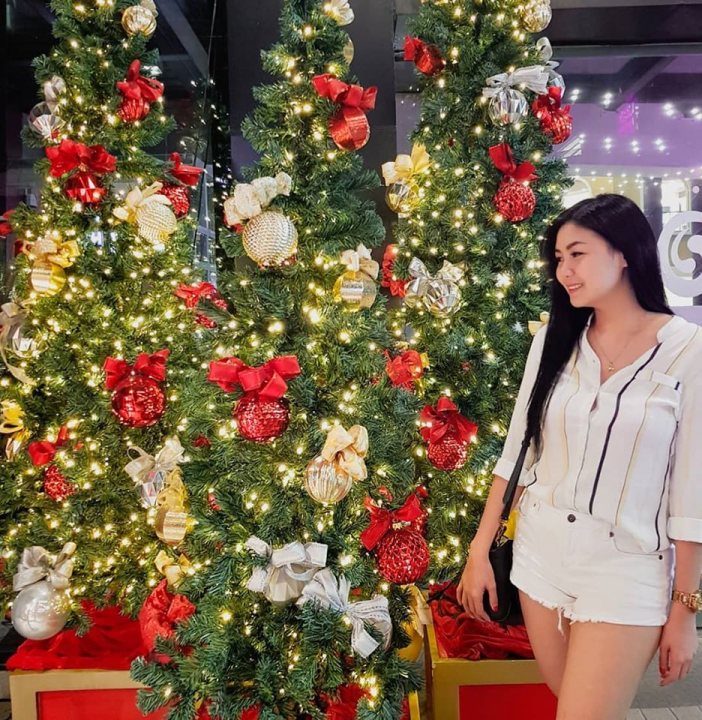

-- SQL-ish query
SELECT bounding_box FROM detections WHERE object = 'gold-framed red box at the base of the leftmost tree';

[10,670,166,720]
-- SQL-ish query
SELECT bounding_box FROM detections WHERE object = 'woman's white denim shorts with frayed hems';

[511,491,674,627]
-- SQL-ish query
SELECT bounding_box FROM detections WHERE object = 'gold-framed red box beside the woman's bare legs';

[425,623,556,720]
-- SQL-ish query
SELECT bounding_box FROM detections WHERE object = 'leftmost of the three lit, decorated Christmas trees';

[0,0,214,639]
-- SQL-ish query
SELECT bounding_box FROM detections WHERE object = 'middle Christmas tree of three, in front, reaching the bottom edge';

[133,0,429,720]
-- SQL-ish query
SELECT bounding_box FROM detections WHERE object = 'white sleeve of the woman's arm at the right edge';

[668,378,702,543]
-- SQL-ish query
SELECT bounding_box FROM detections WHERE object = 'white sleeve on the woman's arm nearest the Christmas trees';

[492,326,547,485]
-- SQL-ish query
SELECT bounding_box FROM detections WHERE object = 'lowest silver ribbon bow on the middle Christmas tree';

[297,568,392,658]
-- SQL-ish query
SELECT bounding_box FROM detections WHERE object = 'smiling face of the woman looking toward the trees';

[556,223,627,307]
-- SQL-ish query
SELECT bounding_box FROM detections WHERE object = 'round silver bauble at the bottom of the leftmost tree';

[12,580,70,640]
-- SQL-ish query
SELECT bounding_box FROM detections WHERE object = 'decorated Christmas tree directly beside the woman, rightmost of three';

[383,0,572,580]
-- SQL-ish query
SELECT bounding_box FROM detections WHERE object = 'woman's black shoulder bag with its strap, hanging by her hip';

[483,435,531,625]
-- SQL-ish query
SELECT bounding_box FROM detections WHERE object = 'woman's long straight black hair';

[526,194,673,450]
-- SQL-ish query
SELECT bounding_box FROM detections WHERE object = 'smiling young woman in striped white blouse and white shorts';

[458,195,702,720]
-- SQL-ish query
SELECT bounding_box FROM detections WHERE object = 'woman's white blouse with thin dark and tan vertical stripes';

[493,315,702,552]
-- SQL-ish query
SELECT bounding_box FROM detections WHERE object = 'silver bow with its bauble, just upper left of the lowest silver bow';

[246,535,327,605]
